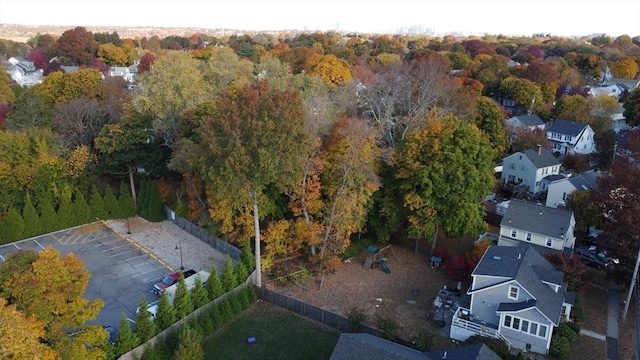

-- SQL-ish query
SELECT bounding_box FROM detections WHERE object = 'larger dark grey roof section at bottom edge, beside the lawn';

[330,333,431,360]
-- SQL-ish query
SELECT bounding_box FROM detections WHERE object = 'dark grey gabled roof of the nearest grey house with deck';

[472,245,564,325]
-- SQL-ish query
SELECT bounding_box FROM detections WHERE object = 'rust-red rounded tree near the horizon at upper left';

[55,26,98,65]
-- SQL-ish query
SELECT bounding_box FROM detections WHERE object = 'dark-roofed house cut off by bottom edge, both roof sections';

[330,333,500,360]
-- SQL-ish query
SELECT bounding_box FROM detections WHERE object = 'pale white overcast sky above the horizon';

[0,0,640,37]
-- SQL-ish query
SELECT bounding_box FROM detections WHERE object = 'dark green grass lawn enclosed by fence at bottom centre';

[202,301,340,360]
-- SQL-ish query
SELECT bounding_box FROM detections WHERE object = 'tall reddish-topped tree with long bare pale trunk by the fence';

[201,81,310,286]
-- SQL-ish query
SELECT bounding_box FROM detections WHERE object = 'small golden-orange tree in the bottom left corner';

[0,296,58,360]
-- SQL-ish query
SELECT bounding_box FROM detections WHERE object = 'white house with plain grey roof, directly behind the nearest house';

[498,199,576,251]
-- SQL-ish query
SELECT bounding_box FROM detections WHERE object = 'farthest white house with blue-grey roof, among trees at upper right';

[547,119,596,155]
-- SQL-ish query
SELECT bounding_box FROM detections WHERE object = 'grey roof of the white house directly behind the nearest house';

[500,199,573,239]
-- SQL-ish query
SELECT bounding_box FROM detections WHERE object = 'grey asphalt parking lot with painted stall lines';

[0,223,173,327]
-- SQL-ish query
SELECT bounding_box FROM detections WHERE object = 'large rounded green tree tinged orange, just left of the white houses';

[394,116,493,252]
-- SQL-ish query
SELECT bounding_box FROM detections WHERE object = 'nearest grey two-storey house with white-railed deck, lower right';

[449,246,575,354]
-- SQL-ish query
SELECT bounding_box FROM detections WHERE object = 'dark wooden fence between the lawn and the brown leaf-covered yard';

[256,286,380,336]
